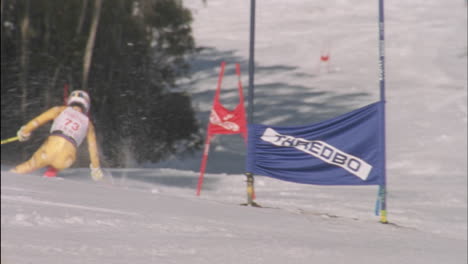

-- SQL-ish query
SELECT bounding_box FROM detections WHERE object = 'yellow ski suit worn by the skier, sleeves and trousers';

[12,106,100,173]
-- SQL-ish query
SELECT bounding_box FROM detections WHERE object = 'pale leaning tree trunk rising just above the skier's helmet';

[81,0,102,90]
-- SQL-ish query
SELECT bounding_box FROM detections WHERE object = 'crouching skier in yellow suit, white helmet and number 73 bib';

[12,90,103,180]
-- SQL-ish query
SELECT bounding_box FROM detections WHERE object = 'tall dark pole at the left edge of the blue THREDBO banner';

[245,0,256,206]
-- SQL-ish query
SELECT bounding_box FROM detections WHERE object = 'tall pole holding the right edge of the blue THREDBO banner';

[379,0,388,224]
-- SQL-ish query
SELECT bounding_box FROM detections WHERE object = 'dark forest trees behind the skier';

[1,0,201,167]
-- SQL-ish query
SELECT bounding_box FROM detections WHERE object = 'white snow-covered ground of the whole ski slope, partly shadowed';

[1,0,467,264]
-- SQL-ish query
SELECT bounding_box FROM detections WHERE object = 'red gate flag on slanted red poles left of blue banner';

[197,61,247,196]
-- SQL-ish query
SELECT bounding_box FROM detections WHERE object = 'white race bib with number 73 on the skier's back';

[50,107,89,147]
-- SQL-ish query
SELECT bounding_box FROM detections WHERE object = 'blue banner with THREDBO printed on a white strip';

[246,102,385,185]
